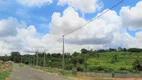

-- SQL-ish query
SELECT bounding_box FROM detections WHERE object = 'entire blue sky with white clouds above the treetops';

[0,0,142,55]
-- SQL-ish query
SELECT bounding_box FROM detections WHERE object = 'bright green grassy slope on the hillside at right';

[87,52,142,70]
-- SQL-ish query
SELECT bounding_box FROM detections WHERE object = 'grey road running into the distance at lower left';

[10,64,70,80]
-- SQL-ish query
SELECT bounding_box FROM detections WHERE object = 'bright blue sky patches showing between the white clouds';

[0,0,139,35]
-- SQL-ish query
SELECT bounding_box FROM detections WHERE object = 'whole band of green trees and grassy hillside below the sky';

[0,47,142,73]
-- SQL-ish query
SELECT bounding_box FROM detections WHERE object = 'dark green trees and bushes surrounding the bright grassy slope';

[0,47,142,72]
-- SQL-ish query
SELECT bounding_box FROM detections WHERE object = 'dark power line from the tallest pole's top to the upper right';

[64,0,124,36]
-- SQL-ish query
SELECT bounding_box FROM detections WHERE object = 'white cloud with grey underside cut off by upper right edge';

[120,1,142,30]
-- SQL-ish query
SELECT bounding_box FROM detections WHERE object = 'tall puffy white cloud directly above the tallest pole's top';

[50,7,86,34]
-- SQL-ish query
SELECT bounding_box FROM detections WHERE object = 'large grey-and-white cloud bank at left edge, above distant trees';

[0,17,45,55]
